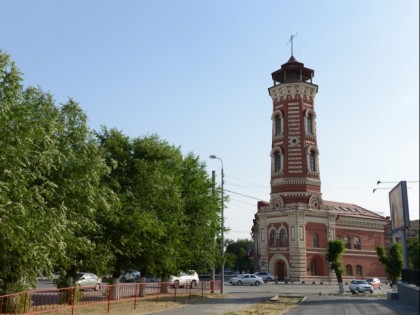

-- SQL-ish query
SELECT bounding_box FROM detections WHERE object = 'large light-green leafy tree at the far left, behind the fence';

[0,52,113,293]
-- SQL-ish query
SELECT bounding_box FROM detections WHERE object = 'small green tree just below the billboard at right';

[376,243,403,286]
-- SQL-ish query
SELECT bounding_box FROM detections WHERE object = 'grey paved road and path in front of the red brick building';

[155,283,419,315]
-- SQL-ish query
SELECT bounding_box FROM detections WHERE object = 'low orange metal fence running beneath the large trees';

[0,280,221,315]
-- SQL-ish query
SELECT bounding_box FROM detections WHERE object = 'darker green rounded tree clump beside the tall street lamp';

[97,128,219,279]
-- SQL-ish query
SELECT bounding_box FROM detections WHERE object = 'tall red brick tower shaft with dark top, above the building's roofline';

[268,56,322,209]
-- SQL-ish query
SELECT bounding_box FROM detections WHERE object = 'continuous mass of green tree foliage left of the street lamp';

[0,51,221,293]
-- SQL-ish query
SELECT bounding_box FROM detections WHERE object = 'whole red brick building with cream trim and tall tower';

[252,56,389,282]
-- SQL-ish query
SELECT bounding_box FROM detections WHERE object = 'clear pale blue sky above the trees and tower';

[0,0,419,239]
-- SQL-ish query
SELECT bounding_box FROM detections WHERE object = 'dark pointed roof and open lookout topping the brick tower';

[271,55,315,83]
